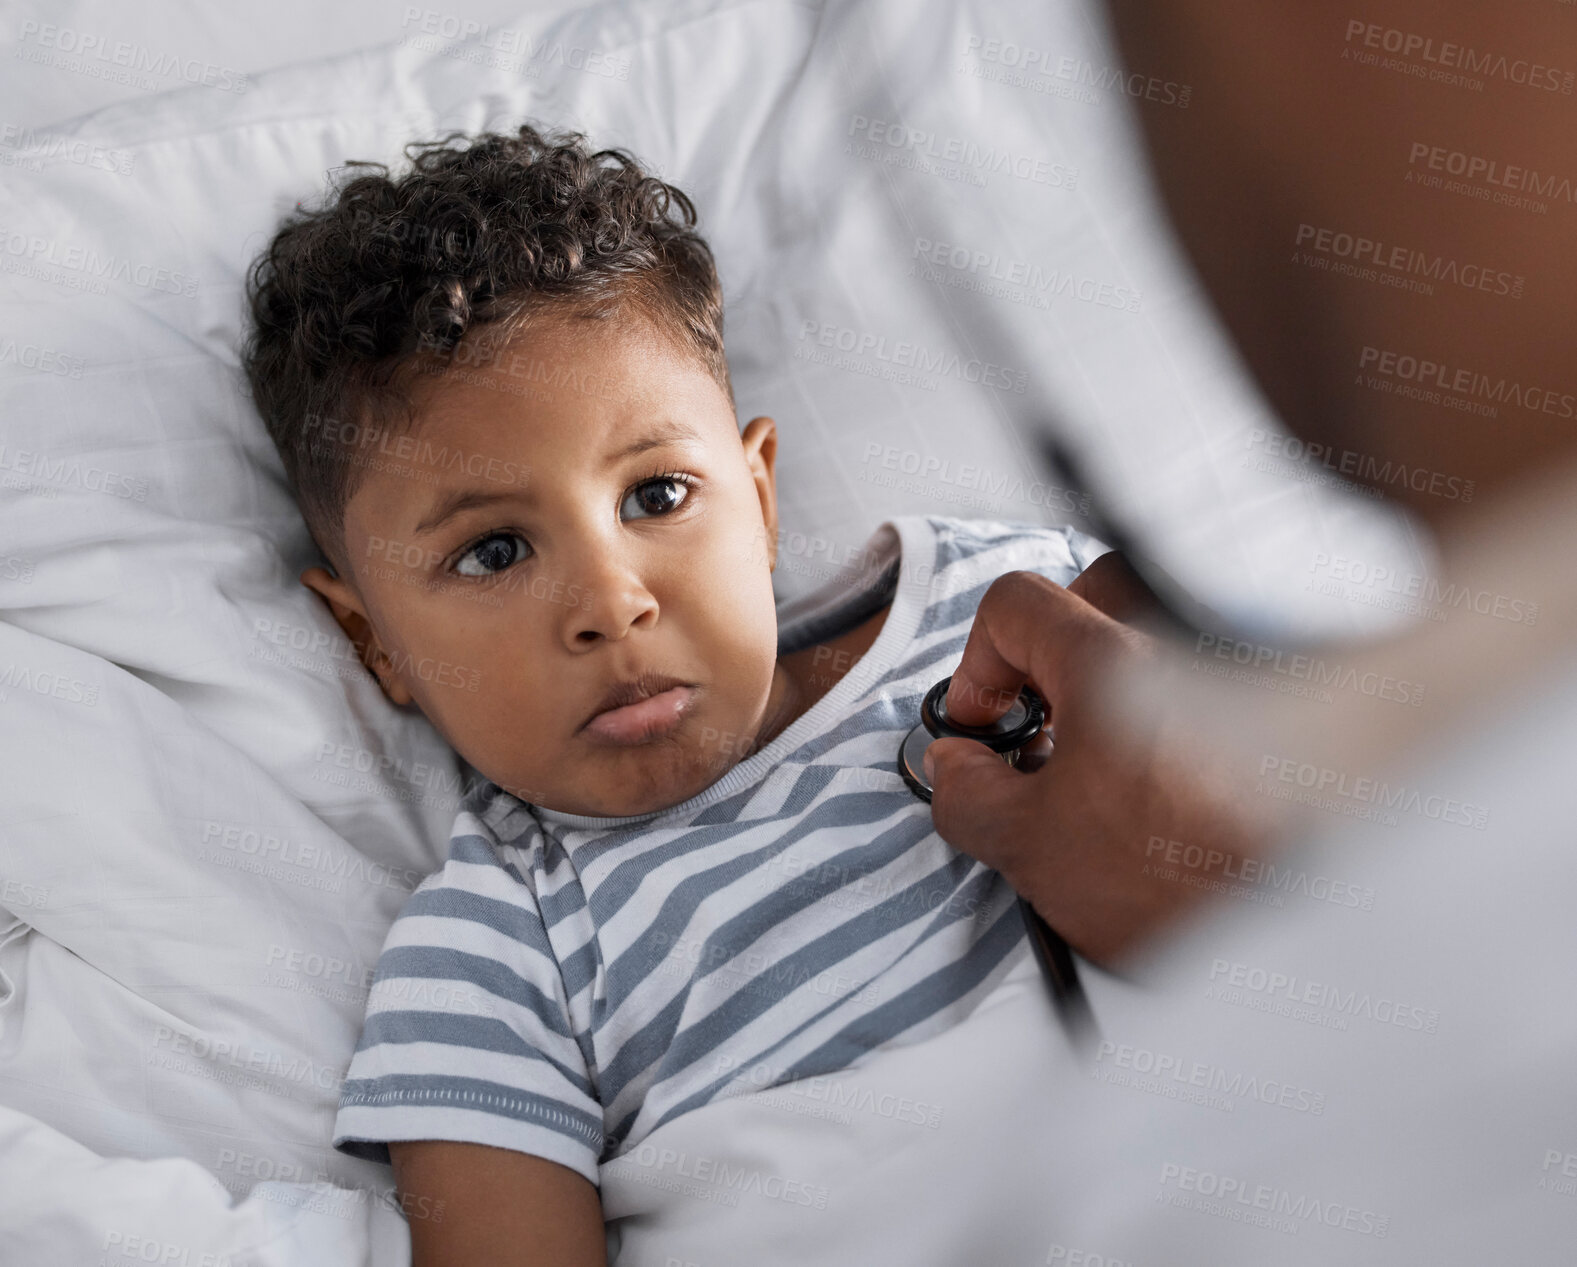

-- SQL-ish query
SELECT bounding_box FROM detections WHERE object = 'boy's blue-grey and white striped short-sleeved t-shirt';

[333,516,1104,1183]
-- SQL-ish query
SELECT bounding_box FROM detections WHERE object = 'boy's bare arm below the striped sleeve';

[390,1139,607,1267]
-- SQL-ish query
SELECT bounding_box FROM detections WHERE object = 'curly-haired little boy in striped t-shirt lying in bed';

[244,126,1102,1267]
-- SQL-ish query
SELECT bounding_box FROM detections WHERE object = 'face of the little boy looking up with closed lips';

[301,316,777,814]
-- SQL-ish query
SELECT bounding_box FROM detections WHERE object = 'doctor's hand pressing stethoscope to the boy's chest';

[926,552,1266,964]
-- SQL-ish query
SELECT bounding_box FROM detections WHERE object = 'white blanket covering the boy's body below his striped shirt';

[601,945,1142,1267]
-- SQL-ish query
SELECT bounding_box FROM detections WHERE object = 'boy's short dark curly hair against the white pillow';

[241,125,733,574]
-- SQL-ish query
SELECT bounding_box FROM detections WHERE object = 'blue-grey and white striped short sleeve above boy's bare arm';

[333,811,604,1183]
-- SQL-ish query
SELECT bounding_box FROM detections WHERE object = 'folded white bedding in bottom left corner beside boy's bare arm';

[0,1106,410,1267]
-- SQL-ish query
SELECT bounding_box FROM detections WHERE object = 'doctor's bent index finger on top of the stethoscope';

[948,571,1123,726]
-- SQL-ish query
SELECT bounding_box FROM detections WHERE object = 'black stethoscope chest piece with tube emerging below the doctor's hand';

[897,674,1101,1052]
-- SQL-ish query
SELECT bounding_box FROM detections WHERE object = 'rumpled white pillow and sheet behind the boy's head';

[0,0,1410,1267]
